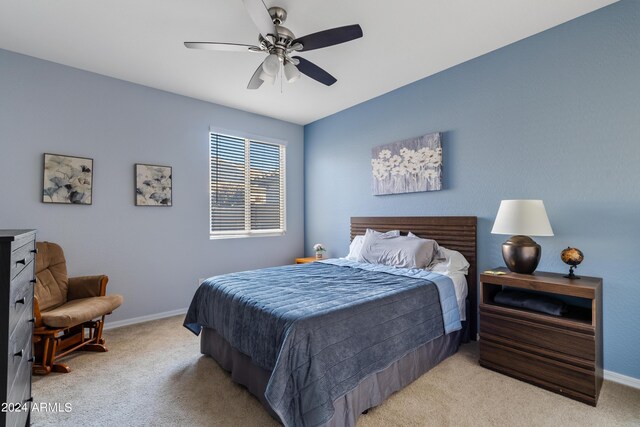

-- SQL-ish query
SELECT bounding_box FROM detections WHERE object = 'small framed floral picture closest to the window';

[135,163,173,206]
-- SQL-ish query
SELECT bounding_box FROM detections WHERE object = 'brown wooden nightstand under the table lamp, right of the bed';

[480,268,602,406]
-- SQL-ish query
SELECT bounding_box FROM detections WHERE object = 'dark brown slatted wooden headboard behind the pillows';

[351,216,478,340]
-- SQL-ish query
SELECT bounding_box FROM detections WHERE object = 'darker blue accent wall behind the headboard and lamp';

[305,0,640,378]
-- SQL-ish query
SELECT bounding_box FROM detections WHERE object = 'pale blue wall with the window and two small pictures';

[0,50,304,321]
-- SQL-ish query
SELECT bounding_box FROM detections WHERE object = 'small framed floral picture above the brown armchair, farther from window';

[42,153,93,205]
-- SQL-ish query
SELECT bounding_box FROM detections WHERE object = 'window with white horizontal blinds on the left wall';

[209,133,285,238]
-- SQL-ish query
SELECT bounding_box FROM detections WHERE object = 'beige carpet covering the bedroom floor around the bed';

[32,316,640,427]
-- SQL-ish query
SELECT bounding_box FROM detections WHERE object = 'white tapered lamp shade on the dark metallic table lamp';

[491,200,553,236]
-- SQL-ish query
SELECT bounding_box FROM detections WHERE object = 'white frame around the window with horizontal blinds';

[207,127,288,240]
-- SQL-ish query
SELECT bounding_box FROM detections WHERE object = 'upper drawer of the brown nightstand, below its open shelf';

[480,308,596,361]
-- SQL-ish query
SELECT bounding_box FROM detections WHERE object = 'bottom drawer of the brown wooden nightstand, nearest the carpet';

[480,339,596,403]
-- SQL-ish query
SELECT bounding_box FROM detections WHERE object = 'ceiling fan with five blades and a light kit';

[184,0,362,89]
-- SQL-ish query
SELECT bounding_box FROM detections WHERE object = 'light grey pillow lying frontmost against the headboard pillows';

[358,233,438,268]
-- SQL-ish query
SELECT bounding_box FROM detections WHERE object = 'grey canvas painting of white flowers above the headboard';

[371,132,442,196]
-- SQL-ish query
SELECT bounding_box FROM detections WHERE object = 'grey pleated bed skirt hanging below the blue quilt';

[200,322,467,427]
